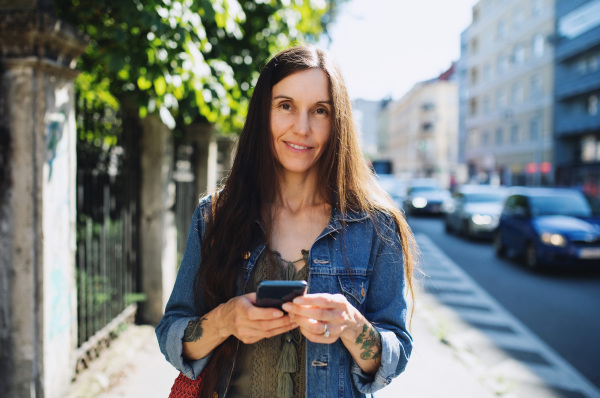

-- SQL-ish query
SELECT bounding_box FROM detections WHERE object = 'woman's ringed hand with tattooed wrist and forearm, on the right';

[283,293,381,374]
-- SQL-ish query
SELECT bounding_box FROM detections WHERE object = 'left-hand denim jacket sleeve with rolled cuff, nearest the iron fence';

[156,198,210,380]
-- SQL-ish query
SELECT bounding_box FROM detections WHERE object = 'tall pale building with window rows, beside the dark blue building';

[459,0,555,185]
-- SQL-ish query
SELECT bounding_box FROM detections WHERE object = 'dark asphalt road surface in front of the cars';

[409,217,600,387]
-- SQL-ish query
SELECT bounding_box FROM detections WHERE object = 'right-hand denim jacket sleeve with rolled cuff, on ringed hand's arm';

[351,213,412,394]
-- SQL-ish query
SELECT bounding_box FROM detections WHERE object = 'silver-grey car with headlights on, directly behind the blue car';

[444,185,507,238]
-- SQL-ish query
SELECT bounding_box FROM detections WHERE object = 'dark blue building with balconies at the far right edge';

[554,0,600,197]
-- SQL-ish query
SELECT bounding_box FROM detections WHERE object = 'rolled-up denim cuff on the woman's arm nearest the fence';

[166,317,212,380]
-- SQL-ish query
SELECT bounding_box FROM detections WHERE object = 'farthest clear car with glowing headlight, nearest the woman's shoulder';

[404,178,450,215]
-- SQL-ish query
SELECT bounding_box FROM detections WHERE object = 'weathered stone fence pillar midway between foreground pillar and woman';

[140,116,177,324]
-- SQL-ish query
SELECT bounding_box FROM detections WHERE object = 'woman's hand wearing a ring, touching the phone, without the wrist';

[283,293,364,343]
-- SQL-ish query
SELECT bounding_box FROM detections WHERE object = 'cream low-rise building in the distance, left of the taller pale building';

[380,65,458,186]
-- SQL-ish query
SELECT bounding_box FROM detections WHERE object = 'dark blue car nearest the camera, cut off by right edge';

[494,188,600,269]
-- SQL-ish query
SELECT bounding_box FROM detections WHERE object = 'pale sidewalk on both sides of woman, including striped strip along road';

[67,236,600,398]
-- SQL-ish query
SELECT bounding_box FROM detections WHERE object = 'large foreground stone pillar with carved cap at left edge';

[0,0,84,398]
